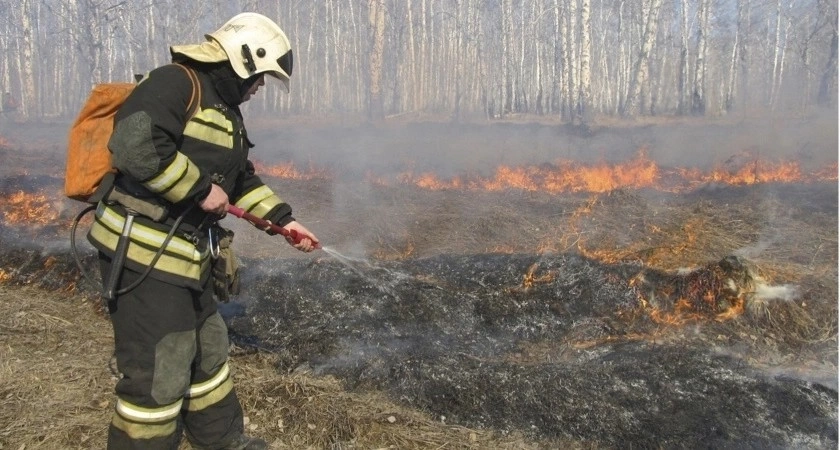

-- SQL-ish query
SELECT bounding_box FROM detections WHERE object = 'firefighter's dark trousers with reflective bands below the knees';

[100,254,243,450]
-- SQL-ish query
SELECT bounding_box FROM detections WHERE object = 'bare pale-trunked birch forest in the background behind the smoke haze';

[0,0,838,123]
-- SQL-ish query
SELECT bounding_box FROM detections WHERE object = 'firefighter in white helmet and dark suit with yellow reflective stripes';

[88,13,318,449]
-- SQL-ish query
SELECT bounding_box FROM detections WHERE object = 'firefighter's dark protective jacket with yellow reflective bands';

[88,63,294,289]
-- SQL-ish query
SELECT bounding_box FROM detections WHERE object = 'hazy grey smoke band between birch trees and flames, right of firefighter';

[246,108,838,179]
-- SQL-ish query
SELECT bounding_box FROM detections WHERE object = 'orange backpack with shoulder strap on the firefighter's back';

[64,64,200,203]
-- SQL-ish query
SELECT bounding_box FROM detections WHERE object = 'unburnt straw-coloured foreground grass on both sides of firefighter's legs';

[0,284,556,450]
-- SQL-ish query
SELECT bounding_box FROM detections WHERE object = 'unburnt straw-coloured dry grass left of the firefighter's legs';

[0,286,116,449]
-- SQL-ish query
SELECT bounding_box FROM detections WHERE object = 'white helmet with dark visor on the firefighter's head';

[171,12,293,92]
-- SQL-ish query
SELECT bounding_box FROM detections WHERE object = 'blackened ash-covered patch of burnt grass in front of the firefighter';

[223,254,838,449]
